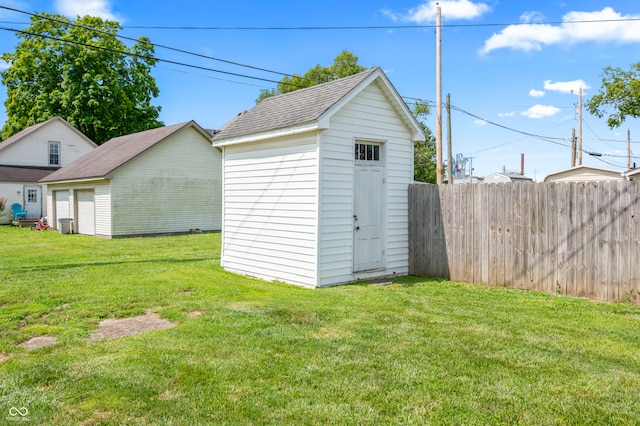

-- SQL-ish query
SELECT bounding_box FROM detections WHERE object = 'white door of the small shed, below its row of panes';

[353,165,385,272]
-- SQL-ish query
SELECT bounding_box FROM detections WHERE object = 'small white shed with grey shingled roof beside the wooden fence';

[213,68,425,287]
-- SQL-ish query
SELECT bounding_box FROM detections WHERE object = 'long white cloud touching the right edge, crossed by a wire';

[480,7,640,54]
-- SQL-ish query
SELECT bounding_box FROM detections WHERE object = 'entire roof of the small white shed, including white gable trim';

[213,68,424,145]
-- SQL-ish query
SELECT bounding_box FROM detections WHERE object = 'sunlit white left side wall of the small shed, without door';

[221,134,318,286]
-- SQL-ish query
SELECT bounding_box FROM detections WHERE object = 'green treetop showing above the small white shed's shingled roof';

[256,50,367,104]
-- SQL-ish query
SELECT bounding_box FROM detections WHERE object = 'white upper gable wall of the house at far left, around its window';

[1,120,95,167]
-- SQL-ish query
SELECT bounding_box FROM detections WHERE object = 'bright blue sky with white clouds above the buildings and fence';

[0,0,640,180]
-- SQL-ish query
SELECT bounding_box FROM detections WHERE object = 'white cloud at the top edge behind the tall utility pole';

[382,0,491,24]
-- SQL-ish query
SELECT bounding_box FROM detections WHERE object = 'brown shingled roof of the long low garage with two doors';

[42,120,211,182]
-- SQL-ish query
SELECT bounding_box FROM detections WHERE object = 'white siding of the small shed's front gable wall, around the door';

[318,84,413,286]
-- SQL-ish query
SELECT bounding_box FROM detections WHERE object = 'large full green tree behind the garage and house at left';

[0,14,162,144]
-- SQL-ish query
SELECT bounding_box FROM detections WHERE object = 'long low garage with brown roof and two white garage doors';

[42,121,221,238]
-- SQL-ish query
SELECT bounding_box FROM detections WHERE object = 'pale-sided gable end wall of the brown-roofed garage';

[111,127,222,236]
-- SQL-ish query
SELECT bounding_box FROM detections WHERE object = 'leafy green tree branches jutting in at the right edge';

[587,62,640,128]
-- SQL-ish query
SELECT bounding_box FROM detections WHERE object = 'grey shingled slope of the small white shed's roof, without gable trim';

[213,68,379,142]
